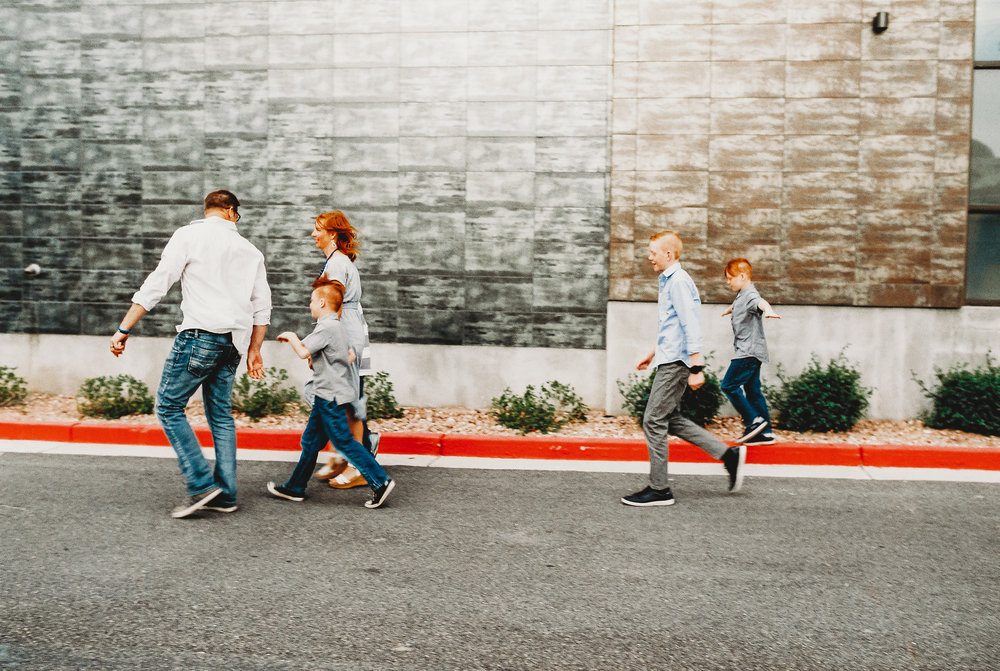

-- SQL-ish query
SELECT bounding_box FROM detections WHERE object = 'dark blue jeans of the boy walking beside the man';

[284,396,389,495]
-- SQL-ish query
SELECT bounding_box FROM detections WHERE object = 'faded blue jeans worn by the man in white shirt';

[156,329,240,505]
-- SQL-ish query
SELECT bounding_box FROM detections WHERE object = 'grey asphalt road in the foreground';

[0,453,1000,671]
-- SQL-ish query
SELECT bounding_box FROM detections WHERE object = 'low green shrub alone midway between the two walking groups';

[490,381,588,434]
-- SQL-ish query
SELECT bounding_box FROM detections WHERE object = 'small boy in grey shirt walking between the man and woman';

[267,277,396,508]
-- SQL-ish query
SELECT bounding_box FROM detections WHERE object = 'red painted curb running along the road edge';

[0,421,1000,471]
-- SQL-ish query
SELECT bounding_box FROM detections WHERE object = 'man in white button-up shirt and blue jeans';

[111,191,271,517]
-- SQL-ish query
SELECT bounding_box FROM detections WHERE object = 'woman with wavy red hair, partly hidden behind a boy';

[307,210,379,489]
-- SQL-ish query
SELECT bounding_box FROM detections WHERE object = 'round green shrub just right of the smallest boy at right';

[765,352,871,432]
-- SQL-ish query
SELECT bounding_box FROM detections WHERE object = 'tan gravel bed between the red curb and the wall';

[0,394,1000,447]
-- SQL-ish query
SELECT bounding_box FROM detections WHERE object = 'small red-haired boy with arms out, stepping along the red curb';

[721,259,781,445]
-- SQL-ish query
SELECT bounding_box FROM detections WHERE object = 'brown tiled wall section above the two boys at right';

[609,0,973,307]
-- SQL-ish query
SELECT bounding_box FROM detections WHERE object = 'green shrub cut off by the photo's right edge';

[914,353,1000,436]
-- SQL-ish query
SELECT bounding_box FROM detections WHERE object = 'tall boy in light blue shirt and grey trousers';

[621,231,746,506]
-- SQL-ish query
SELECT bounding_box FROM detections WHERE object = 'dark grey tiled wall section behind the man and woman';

[0,0,612,349]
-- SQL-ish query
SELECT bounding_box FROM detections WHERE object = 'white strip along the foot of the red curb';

[0,440,1000,484]
